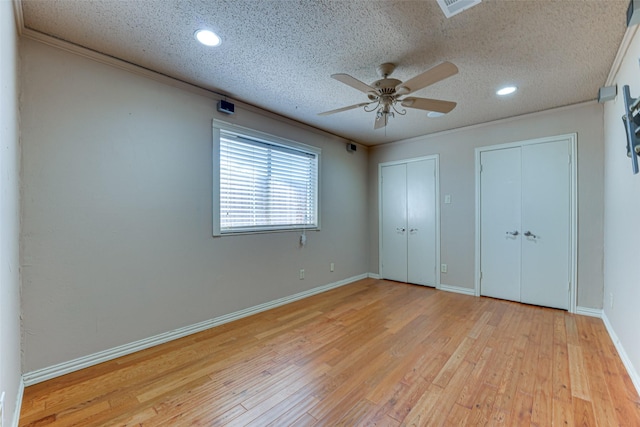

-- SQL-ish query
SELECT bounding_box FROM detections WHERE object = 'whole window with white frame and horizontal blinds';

[213,121,320,235]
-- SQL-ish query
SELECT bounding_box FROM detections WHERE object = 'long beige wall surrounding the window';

[21,40,369,372]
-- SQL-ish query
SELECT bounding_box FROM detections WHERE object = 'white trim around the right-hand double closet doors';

[474,133,578,313]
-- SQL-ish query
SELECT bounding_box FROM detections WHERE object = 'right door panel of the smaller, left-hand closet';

[407,159,437,286]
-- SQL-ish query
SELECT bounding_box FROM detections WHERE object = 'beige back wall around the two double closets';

[369,103,603,308]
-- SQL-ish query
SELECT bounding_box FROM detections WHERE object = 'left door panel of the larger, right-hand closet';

[480,147,521,301]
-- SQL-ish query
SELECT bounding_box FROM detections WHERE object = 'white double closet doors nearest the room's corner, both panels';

[379,157,439,286]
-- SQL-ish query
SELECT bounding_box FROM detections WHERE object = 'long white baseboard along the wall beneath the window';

[22,273,371,386]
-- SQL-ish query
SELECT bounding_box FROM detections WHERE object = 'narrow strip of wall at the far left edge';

[0,1,22,425]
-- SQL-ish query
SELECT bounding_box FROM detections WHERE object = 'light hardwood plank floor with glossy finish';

[20,279,640,426]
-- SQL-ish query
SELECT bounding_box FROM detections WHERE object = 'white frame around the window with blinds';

[211,119,322,237]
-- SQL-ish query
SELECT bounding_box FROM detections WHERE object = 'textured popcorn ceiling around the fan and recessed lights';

[21,0,628,145]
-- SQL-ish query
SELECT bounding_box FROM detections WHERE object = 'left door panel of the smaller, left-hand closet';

[380,164,408,282]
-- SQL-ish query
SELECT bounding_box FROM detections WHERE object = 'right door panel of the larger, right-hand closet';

[521,140,571,310]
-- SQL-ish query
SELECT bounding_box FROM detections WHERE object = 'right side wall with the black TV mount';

[604,27,640,391]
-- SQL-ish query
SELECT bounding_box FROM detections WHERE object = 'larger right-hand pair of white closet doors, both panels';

[480,138,572,310]
